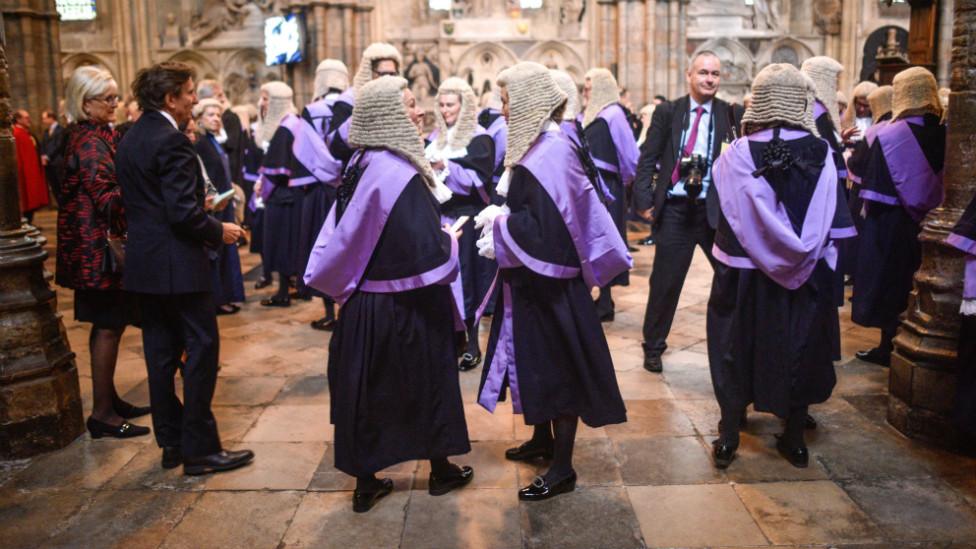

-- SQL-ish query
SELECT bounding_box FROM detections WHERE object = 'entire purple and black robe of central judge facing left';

[478,132,632,426]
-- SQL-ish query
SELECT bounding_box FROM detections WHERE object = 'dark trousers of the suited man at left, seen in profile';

[140,292,221,458]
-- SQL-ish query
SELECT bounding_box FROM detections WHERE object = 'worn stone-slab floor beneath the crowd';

[0,210,976,549]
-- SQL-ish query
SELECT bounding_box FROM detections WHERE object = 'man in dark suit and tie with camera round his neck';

[634,51,742,372]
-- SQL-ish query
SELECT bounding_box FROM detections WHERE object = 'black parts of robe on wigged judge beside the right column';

[851,114,946,329]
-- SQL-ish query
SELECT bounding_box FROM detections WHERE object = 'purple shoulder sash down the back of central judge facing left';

[496,132,633,287]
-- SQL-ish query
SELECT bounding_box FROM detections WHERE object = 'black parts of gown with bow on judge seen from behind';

[706,135,842,418]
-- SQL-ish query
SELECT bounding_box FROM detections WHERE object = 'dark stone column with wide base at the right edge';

[888,0,976,448]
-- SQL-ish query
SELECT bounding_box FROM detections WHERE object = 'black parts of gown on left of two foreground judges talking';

[328,175,471,476]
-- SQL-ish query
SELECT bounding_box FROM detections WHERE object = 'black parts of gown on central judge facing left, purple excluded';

[478,166,627,427]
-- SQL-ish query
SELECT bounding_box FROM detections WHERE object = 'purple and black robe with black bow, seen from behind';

[706,129,839,417]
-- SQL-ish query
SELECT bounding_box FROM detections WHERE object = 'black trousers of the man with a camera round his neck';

[643,198,715,356]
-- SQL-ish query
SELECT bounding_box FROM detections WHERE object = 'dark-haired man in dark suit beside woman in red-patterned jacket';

[115,63,254,475]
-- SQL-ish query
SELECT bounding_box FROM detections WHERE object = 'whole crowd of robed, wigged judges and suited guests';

[17,39,976,512]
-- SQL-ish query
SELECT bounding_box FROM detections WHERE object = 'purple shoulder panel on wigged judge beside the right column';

[861,116,945,223]
